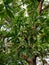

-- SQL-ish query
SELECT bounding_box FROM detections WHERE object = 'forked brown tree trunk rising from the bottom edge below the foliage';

[21,54,37,65]
